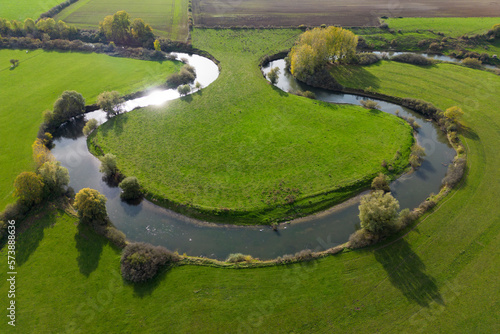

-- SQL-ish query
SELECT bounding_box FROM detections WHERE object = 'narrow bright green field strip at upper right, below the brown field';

[384,17,500,37]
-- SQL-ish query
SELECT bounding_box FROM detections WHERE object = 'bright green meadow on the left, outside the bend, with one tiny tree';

[0,50,180,210]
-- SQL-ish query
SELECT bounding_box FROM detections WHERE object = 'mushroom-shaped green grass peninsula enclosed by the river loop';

[91,30,413,224]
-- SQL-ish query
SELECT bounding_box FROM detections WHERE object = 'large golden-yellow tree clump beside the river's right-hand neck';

[289,27,358,76]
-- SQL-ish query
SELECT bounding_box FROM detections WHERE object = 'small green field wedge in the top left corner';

[0,0,63,21]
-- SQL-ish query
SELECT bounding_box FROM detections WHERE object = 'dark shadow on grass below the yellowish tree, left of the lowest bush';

[75,224,107,277]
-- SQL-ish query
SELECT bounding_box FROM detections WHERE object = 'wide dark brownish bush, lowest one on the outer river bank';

[120,242,179,283]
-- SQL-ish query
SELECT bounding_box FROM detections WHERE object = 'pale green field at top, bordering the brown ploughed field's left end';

[55,0,188,41]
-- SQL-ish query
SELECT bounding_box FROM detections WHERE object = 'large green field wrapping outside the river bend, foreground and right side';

[0,39,500,333]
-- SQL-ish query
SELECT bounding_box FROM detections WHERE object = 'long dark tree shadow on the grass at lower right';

[375,239,444,307]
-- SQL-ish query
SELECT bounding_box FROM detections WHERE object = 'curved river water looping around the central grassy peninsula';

[52,54,455,259]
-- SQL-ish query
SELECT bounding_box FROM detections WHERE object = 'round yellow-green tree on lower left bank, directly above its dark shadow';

[74,188,108,223]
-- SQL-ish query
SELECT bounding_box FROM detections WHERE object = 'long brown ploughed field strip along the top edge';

[193,0,500,27]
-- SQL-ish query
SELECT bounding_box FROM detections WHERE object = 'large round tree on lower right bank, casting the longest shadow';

[359,190,399,234]
